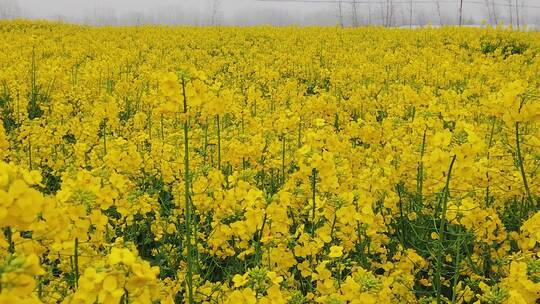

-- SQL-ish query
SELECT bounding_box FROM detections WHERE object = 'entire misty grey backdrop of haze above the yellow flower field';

[0,0,540,26]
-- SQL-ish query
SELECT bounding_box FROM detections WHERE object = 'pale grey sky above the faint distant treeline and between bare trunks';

[7,0,540,23]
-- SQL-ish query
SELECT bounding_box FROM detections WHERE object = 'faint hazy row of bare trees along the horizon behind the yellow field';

[0,0,540,27]
